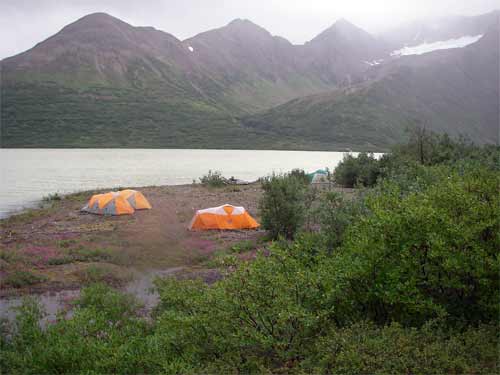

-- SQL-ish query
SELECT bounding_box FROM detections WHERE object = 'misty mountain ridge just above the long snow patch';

[380,10,500,49]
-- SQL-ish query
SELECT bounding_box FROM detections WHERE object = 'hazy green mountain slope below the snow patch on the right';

[243,22,500,150]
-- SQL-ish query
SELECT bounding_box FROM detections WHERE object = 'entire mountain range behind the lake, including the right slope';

[0,13,498,150]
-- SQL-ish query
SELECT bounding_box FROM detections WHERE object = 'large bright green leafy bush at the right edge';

[336,168,500,325]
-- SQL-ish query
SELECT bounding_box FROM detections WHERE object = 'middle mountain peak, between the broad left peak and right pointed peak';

[184,19,331,113]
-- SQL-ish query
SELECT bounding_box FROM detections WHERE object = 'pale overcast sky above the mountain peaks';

[0,0,500,59]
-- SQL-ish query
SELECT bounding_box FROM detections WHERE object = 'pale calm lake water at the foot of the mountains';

[0,149,368,217]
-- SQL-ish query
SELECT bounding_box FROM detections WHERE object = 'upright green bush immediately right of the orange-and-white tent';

[259,174,308,239]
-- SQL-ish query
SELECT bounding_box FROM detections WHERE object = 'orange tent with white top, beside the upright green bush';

[189,204,260,230]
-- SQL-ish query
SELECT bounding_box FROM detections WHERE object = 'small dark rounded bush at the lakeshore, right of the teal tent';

[334,152,380,188]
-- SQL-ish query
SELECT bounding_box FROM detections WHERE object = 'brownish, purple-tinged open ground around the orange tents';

[0,184,264,297]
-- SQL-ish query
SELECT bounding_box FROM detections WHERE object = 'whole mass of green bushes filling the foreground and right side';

[0,132,500,374]
